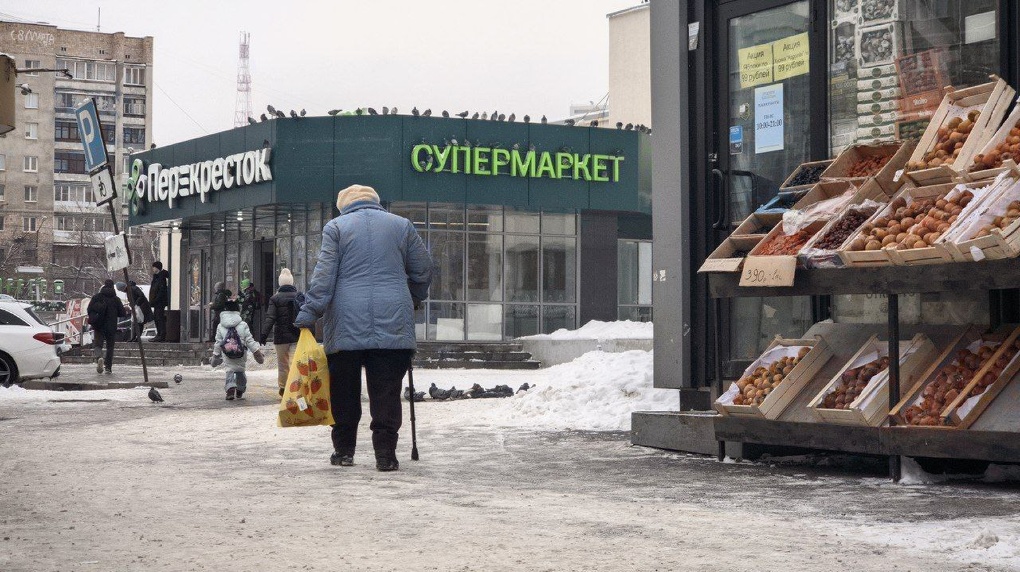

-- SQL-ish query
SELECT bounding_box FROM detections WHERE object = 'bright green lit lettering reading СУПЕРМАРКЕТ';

[411,143,623,183]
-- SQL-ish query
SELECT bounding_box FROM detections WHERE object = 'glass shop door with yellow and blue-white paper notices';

[715,0,825,365]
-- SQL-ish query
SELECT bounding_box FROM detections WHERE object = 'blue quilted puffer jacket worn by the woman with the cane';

[294,201,432,354]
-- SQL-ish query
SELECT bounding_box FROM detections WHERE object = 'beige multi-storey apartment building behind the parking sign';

[0,20,153,296]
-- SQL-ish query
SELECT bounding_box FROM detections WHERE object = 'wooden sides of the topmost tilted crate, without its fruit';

[904,75,1016,187]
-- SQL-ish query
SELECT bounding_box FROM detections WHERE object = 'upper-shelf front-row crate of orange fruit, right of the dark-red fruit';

[839,184,956,266]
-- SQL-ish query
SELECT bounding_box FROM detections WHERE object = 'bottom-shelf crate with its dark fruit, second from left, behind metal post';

[808,333,935,427]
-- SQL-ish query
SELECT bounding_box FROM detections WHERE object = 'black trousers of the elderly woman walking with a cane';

[326,350,414,459]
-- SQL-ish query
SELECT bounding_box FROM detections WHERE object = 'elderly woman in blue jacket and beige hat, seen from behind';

[294,185,432,471]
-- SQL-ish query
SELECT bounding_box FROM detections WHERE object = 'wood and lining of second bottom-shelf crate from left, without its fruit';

[808,333,935,427]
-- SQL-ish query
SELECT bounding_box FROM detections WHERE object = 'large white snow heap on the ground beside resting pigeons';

[424,351,679,431]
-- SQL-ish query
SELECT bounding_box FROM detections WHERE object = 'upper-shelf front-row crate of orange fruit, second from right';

[888,183,996,266]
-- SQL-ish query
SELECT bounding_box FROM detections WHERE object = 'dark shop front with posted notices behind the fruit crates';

[652,0,1020,401]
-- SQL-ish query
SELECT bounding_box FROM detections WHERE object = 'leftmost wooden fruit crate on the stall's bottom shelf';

[713,336,832,419]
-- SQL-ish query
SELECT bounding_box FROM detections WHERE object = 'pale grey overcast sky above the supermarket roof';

[0,0,640,145]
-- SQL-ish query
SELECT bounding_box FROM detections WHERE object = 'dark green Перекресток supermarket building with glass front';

[126,115,652,342]
